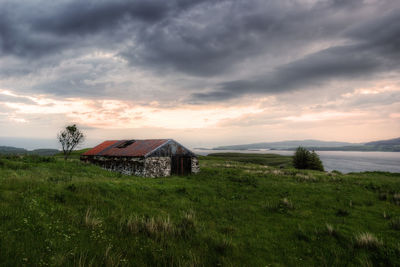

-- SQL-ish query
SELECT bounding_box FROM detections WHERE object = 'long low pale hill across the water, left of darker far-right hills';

[213,139,360,150]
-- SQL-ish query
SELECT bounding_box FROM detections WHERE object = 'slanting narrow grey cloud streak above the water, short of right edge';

[193,46,380,101]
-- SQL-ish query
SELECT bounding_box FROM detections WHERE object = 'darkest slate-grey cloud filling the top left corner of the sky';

[0,0,208,58]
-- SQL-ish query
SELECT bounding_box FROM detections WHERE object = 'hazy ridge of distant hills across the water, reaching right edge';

[213,138,400,152]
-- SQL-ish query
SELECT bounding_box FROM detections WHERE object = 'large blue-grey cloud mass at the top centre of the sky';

[121,1,356,77]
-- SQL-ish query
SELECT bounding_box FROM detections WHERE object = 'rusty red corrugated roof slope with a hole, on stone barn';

[82,139,169,157]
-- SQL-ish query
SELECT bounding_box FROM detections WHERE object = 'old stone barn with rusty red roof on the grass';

[80,139,199,177]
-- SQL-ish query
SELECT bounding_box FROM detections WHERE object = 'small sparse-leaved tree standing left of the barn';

[57,124,85,160]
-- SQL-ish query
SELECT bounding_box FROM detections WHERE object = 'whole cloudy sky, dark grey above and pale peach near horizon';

[0,0,400,147]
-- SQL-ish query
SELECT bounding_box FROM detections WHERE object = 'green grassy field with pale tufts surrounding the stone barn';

[0,153,400,266]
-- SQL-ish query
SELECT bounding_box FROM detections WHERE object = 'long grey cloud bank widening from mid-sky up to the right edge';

[192,7,400,101]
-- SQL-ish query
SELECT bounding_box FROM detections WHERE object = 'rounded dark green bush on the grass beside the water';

[293,147,324,171]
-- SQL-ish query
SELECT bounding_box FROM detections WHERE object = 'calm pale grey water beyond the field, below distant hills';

[193,149,400,173]
